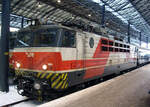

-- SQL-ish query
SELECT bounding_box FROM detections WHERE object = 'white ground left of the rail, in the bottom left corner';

[0,86,26,107]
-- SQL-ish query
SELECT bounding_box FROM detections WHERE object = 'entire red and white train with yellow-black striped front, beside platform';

[10,25,150,99]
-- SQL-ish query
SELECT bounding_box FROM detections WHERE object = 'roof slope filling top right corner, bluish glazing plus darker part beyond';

[98,0,150,40]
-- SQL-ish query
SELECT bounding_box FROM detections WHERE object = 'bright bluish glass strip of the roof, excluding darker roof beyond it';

[93,0,150,36]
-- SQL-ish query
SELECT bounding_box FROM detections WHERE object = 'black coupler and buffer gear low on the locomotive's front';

[17,76,51,99]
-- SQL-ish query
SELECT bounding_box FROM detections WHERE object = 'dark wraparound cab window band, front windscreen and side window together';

[15,27,76,48]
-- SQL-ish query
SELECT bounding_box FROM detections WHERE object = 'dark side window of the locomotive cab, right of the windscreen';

[62,30,76,48]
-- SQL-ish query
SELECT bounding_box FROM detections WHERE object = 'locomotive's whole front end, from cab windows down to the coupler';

[10,25,77,97]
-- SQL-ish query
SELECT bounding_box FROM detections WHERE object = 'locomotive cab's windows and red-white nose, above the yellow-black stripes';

[10,26,77,71]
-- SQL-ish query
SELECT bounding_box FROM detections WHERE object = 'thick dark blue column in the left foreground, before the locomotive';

[0,0,10,92]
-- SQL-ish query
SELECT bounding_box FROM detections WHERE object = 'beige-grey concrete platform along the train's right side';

[39,64,150,107]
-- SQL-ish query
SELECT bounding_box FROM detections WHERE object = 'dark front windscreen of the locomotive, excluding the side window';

[15,28,59,47]
